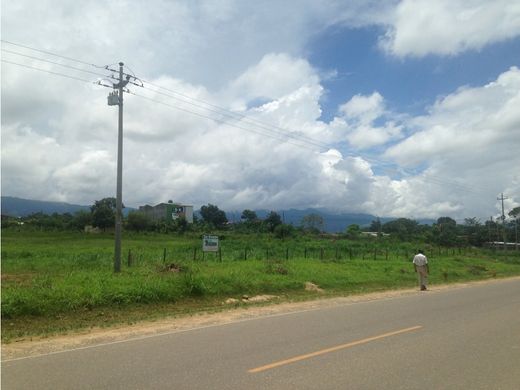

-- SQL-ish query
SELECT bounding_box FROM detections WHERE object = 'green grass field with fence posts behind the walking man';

[2,230,520,342]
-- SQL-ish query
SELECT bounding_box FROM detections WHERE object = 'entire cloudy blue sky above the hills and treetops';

[1,0,520,222]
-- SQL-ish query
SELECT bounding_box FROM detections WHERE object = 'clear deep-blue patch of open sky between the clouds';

[307,26,520,121]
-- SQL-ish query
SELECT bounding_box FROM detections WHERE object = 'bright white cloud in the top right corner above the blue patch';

[381,0,520,57]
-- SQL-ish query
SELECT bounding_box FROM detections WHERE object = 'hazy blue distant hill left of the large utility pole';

[2,196,90,217]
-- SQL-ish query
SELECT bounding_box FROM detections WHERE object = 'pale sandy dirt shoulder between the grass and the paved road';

[2,277,520,361]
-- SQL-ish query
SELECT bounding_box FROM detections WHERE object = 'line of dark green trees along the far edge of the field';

[2,198,520,247]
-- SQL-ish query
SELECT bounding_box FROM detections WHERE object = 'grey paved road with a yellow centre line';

[2,279,520,390]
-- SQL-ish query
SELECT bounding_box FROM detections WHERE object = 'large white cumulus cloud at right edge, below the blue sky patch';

[384,67,520,218]
